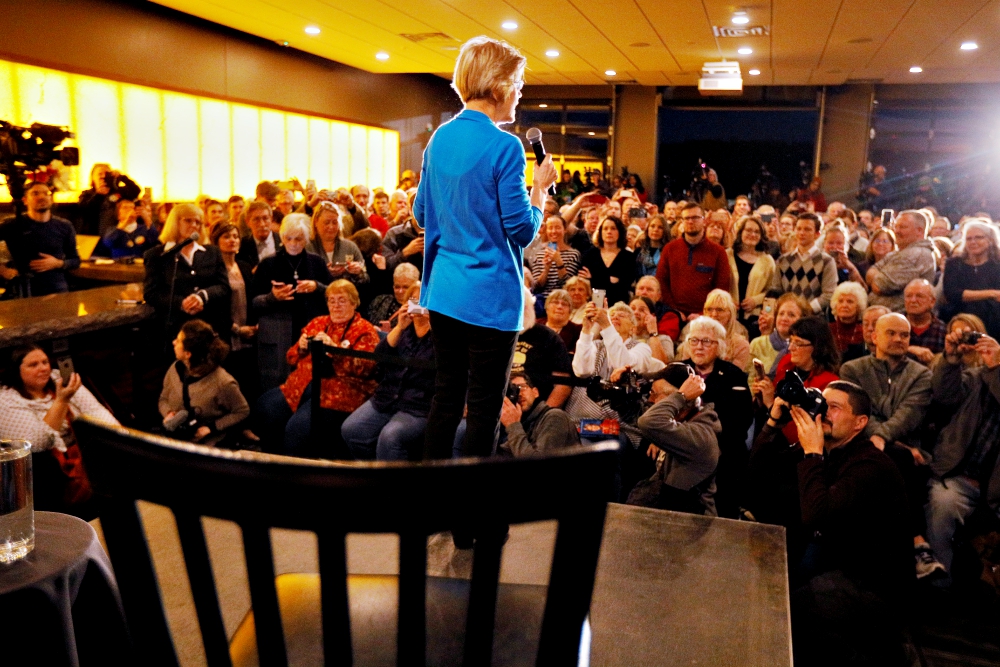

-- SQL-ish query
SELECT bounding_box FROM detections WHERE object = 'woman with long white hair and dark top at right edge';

[943,218,1000,338]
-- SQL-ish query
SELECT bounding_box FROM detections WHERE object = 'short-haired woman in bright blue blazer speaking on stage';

[413,37,556,458]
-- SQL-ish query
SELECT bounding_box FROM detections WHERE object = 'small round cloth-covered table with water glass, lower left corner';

[0,512,133,667]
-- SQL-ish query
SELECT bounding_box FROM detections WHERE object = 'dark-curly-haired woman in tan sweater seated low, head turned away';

[159,320,250,448]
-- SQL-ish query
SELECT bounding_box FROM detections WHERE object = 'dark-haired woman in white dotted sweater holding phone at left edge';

[0,344,118,520]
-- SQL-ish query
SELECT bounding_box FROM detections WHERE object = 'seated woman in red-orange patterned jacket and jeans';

[256,280,379,458]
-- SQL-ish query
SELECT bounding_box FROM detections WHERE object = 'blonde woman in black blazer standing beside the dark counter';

[143,204,232,344]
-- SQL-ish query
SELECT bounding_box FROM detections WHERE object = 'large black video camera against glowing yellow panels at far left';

[0,120,80,213]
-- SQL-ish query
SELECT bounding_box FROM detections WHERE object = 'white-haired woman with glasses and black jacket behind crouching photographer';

[683,316,753,518]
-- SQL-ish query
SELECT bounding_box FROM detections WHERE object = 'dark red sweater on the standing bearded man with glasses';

[656,238,729,315]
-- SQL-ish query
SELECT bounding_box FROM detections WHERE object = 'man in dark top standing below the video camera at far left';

[0,181,80,297]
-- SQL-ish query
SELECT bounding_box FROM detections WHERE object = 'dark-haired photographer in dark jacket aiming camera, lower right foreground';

[788,381,914,665]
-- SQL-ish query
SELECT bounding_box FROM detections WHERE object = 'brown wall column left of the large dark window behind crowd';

[611,85,659,194]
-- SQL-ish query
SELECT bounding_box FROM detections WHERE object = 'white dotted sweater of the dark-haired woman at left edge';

[0,371,118,452]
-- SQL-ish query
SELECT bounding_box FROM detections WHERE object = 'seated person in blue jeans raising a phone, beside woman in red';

[341,284,434,461]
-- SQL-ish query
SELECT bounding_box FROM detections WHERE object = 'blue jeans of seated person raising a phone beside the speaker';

[340,400,427,461]
